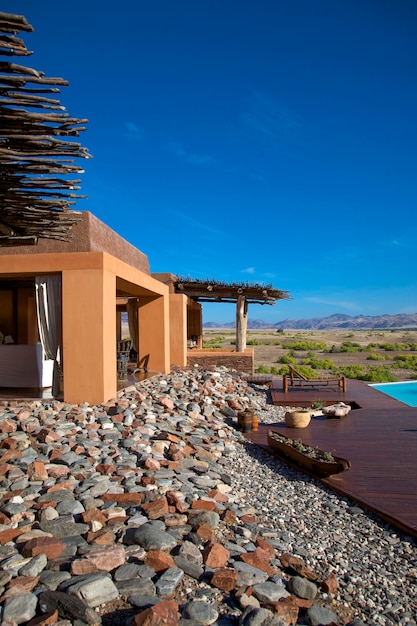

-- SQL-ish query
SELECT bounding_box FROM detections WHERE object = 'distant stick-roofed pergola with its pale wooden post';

[174,277,291,352]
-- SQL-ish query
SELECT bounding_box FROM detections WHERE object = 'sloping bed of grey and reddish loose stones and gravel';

[0,368,417,626]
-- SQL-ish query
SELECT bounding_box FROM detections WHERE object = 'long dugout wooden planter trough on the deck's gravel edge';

[268,430,351,478]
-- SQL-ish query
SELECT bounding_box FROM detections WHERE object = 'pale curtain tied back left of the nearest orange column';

[35,275,62,397]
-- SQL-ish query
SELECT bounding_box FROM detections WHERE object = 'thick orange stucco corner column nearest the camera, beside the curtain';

[62,269,117,404]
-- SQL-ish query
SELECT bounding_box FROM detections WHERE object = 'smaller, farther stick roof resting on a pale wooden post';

[174,277,291,305]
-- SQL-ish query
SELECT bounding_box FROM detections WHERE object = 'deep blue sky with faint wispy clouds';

[9,0,417,322]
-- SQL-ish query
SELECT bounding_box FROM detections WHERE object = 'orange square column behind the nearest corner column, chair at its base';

[138,296,170,374]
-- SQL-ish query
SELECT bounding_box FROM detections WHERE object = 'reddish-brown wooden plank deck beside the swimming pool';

[245,379,417,537]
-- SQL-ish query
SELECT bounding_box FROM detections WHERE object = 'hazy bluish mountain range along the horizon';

[203,313,417,330]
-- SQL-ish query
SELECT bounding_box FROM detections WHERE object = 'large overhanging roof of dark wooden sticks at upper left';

[0,12,90,246]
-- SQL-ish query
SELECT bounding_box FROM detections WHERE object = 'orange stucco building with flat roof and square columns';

[0,212,192,404]
